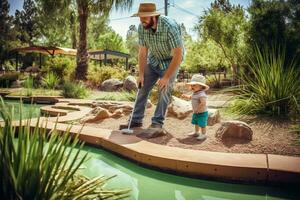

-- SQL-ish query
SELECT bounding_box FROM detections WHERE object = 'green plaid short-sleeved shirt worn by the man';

[138,16,184,70]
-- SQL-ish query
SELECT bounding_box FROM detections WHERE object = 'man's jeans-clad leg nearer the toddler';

[152,69,178,125]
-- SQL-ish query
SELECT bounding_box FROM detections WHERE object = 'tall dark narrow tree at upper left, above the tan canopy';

[15,0,39,45]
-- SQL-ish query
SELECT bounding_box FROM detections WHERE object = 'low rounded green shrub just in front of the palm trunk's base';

[62,82,88,99]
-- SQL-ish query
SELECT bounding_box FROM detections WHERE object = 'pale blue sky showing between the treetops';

[8,0,251,40]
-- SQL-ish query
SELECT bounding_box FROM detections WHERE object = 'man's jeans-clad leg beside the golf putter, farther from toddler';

[132,65,159,123]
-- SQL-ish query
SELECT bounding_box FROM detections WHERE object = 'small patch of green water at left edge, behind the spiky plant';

[0,100,44,120]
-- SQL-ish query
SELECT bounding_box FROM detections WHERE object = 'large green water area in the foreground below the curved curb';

[78,147,300,200]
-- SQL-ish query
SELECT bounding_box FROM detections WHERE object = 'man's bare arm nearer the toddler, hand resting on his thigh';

[158,47,182,89]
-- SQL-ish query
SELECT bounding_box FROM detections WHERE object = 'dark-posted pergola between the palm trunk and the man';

[88,49,130,69]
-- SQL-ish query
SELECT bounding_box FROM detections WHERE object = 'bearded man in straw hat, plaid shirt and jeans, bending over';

[120,3,183,134]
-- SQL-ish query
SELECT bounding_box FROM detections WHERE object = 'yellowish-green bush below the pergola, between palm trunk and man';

[87,65,128,87]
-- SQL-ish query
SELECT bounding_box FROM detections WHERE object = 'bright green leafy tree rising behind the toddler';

[195,0,247,79]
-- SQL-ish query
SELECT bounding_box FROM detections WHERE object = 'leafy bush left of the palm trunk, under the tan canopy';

[42,56,76,82]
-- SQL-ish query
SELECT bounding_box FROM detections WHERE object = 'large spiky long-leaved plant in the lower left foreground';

[0,99,129,200]
